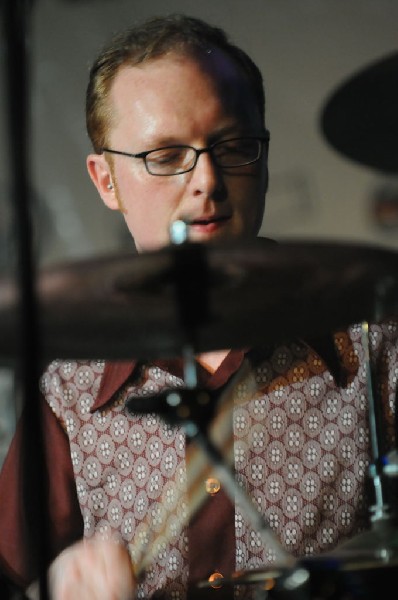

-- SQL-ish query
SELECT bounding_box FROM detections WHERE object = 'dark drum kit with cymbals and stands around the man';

[0,2,398,600]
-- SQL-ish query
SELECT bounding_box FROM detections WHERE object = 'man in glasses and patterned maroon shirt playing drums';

[0,16,397,600]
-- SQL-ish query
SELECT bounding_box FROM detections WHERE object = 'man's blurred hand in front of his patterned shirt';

[49,539,136,600]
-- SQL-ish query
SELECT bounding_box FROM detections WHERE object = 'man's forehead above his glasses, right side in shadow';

[111,49,261,136]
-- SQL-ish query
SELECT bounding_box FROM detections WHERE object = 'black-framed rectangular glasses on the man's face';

[102,131,269,176]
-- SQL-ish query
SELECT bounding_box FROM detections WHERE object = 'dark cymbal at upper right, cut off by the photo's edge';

[320,52,398,173]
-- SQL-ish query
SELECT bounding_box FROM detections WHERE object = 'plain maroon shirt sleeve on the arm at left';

[0,397,83,588]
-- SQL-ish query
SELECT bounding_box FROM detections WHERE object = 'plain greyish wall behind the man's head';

[1,0,398,262]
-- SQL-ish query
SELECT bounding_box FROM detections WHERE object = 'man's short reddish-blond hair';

[86,15,265,153]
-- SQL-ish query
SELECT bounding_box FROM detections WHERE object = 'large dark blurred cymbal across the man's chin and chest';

[0,239,398,362]
